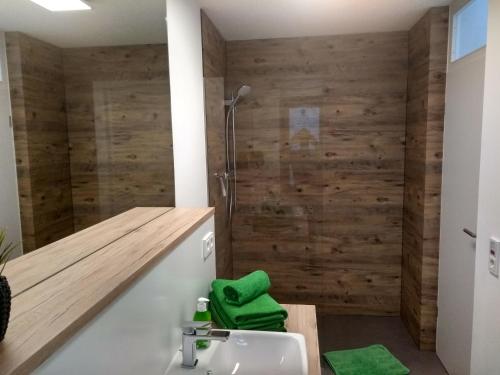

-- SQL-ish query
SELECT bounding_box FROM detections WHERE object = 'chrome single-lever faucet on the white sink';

[182,322,230,368]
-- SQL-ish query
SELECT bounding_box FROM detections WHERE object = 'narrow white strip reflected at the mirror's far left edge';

[0,32,22,256]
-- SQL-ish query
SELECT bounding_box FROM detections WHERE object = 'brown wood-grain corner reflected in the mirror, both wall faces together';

[6,33,174,251]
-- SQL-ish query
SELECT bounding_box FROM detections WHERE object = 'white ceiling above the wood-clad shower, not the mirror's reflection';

[200,0,451,40]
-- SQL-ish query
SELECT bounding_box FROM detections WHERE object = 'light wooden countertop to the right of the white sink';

[282,304,321,375]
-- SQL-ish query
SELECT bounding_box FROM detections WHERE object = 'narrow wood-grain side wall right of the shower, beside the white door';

[401,7,448,350]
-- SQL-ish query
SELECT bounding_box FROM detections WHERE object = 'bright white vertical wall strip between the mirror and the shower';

[167,0,208,207]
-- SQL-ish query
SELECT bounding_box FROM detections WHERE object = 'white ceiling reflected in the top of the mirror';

[0,0,167,47]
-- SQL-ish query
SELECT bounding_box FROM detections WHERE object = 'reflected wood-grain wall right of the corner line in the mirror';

[63,45,174,230]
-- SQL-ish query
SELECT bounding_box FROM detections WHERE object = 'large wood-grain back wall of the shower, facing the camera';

[225,32,408,315]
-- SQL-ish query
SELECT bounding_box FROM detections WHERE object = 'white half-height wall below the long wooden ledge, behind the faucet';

[34,216,215,375]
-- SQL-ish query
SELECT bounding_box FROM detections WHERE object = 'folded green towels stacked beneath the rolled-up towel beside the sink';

[209,279,288,331]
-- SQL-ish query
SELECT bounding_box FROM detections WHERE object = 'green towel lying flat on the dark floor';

[323,345,410,375]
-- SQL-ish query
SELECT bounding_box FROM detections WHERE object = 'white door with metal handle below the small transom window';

[437,48,485,375]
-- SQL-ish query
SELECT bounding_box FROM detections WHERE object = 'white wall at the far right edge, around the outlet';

[471,0,500,375]
